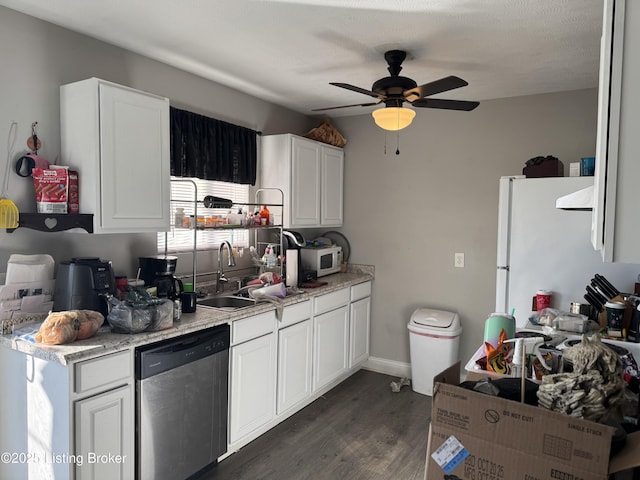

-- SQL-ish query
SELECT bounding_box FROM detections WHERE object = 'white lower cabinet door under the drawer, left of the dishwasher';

[75,385,135,480]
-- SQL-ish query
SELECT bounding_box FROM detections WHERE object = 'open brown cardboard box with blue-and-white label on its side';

[425,362,640,480]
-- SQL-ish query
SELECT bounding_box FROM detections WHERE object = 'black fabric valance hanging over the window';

[171,107,258,185]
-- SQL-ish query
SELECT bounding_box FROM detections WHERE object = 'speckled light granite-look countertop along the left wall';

[0,265,374,365]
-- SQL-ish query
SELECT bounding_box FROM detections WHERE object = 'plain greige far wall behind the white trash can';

[333,89,597,364]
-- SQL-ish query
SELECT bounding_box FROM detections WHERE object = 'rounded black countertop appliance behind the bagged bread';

[53,257,116,318]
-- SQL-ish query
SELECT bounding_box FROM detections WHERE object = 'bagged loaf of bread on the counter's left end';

[36,310,104,345]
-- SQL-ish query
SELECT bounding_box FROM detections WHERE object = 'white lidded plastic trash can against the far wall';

[407,308,462,395]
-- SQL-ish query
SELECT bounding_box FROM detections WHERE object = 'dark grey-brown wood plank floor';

[203,370,431,480]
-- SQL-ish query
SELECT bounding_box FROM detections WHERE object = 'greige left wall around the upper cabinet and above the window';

[0,7,317,275]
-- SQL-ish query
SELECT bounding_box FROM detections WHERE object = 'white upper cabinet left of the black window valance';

[60,78,171,233]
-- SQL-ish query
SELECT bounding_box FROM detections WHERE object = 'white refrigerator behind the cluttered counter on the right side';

[496,177,640,327]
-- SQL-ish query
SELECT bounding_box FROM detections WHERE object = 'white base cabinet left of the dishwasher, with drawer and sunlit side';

[0,348,135,480]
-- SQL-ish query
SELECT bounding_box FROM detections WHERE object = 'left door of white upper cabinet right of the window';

[290,137,321,227]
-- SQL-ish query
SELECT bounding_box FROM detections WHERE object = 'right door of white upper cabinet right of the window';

[320,147,344,227]
